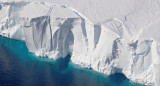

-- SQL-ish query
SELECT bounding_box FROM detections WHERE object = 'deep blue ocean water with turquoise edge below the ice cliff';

[0,36,140,86]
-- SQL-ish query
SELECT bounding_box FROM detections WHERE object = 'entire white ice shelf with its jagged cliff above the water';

[0,0,160,86]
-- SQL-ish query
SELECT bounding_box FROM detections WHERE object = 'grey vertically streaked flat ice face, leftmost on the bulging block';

[24,16,52,52]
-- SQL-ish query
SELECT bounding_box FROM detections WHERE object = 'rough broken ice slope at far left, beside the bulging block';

[0,2,26,40]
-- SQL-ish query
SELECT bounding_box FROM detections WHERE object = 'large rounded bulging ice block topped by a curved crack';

[20,3,91,59]
